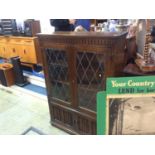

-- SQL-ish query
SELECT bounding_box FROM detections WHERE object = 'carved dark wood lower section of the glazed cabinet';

[50,103,96,135]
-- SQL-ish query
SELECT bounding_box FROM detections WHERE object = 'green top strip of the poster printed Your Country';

[106,76,155,95]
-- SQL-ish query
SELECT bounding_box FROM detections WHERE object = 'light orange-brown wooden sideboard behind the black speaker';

[0,36,41,64]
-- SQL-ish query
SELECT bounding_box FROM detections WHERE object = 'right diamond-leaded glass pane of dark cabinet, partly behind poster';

[76,52,104,111]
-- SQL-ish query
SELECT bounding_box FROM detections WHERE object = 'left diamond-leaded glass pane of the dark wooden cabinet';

[46,48,71,102]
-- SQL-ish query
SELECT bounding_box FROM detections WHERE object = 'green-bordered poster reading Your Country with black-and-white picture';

[97,76,155,135]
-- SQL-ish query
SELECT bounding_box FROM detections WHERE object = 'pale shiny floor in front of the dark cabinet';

[0,85,68,135]
